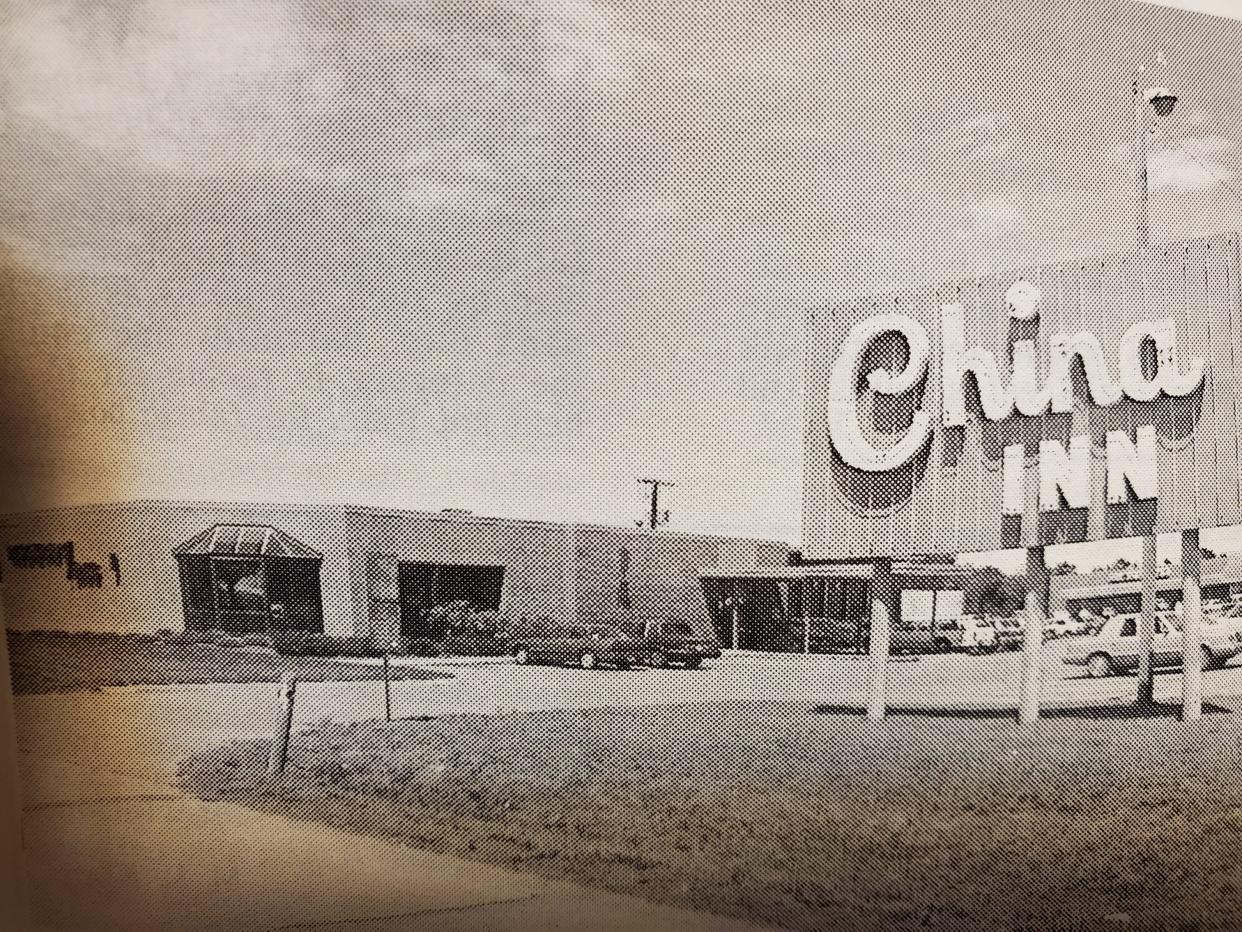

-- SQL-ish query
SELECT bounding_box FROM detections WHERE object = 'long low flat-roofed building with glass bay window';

[2,501,789,644]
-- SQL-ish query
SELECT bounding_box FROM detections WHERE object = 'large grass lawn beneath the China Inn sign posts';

[183,703,1242,931]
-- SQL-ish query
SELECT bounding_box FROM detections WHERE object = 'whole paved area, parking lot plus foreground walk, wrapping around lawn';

[16,644,1242,932]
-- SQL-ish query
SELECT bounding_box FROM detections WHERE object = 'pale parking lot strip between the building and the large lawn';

[16,641,1242,775]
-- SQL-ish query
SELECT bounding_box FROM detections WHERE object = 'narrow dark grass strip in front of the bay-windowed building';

[9,631,443,695]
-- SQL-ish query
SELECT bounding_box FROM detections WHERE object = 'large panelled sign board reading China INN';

[802,235,1242,558]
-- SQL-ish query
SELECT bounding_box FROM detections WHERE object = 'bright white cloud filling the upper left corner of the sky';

[0,0,315,169]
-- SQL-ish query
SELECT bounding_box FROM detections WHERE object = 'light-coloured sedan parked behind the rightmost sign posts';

[1063,611,1242,676]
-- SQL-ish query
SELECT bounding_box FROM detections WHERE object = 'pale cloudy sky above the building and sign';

[0,0,1242,574]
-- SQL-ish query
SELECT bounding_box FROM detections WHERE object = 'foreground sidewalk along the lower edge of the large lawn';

[22,756,775,932]
